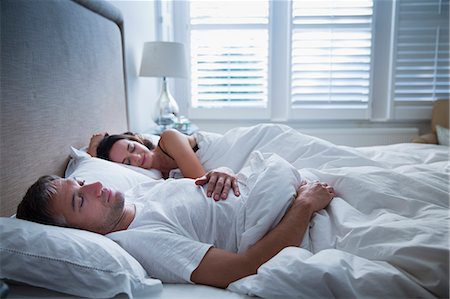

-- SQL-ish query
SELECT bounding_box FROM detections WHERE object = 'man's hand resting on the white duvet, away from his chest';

[294,181,336,213]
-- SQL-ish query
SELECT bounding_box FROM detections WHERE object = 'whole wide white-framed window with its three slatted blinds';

[172,0,450,121]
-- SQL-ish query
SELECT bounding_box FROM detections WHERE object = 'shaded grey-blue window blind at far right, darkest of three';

[394,0,450,102]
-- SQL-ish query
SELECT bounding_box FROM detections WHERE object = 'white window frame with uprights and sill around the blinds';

[171,0,438,122]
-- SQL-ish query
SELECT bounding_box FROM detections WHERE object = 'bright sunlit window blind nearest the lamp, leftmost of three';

[189,0,269,107]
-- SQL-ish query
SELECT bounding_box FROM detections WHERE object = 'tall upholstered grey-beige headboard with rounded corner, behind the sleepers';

[0,0,128,216]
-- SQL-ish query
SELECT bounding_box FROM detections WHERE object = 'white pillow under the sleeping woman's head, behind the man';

[65,147,161,191]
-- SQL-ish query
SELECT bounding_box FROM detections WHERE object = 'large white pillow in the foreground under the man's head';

[0,217,162,298]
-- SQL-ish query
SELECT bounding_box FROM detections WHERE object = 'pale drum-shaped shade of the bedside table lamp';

[139,42,187,78]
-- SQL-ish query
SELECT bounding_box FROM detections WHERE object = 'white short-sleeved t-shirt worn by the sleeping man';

[108,179,241,283]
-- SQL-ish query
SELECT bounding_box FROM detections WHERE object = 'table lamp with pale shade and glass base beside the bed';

[139,42,187,128]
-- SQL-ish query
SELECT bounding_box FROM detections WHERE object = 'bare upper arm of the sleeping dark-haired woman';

[160,129,206,179]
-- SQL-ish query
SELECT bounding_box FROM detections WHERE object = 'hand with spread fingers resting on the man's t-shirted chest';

[195,168,241,201]
